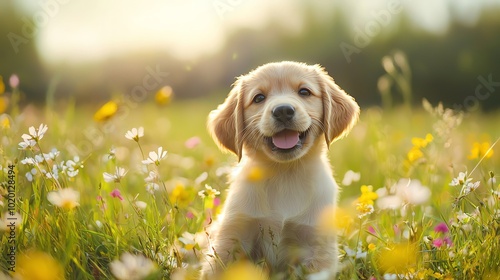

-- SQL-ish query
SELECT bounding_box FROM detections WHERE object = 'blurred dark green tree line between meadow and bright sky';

[0,2,500,110]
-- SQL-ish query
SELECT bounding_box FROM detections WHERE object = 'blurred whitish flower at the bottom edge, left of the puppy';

[109,253,156,280]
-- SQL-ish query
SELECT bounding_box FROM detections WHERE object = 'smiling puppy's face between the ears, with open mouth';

[242,64,323,162]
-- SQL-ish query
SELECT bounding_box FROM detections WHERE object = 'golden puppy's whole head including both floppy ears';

[208,62,359,162]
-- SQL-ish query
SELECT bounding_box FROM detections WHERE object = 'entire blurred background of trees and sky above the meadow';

[0,0,500,110]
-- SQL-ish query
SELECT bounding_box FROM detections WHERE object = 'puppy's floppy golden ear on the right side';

[316,65,359,145]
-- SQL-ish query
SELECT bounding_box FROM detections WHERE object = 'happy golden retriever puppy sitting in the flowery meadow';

[201,61,359,279]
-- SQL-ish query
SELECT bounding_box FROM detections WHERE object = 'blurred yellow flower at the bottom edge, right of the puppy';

[375,243,417,273]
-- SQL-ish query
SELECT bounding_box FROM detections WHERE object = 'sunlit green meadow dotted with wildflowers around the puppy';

[0,96,500,279]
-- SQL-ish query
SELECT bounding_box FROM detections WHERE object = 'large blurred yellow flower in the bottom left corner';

[14,251,64,280]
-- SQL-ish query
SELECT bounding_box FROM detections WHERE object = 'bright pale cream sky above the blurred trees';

[13,0,499,62]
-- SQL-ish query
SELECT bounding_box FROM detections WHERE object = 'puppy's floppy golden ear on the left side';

[207,78,244,160]
